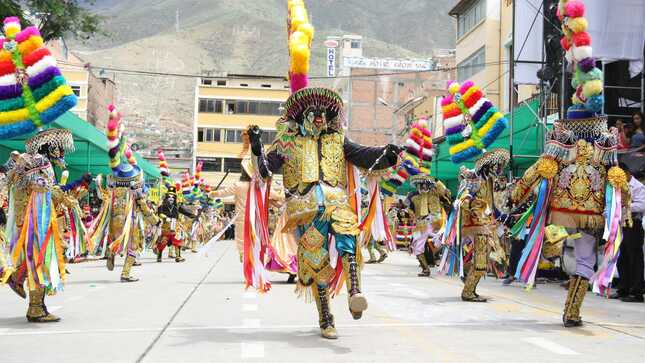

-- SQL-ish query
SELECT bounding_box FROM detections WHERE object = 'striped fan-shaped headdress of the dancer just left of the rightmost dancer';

[441,81,508,164]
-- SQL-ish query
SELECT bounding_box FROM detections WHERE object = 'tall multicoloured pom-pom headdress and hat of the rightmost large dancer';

[557,0,607,142]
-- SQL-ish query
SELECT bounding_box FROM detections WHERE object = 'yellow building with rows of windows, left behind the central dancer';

[194,75,289,193]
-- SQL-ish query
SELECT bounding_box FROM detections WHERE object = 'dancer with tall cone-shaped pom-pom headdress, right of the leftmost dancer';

[91,105,159,282]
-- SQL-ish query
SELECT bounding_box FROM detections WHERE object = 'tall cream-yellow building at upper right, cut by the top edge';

[449,0,536,117]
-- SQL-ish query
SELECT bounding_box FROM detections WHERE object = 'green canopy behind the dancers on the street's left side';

[0,112,160,184]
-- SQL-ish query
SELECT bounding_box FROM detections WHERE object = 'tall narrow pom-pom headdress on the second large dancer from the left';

[107,105,143,187]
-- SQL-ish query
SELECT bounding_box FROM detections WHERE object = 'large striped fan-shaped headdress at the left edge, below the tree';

[0,17,76,139]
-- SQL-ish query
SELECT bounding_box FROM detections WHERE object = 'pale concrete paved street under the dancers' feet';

[0,241,645,363]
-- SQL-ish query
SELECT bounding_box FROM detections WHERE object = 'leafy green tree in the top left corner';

[0,0,104,41]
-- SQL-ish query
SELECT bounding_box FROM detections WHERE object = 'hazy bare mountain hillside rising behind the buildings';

[73,0,455,155]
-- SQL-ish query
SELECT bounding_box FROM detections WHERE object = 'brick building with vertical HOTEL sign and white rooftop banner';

[325,35,454,145]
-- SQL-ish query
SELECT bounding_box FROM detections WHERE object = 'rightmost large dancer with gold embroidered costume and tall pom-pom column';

[512,0,631,327]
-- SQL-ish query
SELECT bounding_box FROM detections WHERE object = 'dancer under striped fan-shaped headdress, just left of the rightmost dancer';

[439,77,510,302]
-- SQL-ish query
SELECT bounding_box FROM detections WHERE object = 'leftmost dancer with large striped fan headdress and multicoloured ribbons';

[0,17,76,323]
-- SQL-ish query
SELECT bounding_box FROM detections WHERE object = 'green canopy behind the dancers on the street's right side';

[397,100,544,195]
